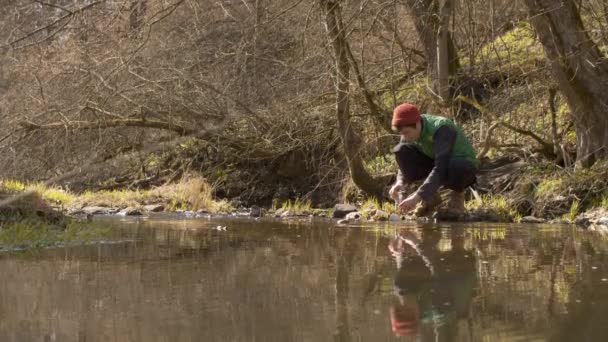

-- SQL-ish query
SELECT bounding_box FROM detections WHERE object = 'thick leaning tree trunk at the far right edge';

[525,0,608,167]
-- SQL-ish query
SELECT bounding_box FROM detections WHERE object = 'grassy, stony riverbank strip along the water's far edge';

[0,166,608,245]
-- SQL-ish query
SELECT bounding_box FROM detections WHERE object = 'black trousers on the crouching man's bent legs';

[394,143,477,192]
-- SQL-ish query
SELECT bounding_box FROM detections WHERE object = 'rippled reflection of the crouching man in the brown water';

[389,228,476,341]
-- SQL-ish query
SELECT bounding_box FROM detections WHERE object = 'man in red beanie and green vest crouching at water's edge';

[389,103,479,216]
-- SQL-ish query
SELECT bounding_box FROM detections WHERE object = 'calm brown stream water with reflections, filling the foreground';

[0,216,608,341]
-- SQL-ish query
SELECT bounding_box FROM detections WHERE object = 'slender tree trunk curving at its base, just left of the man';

[320,0,383,198]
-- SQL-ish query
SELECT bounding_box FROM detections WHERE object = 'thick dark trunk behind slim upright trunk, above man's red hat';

[405,0,460,94]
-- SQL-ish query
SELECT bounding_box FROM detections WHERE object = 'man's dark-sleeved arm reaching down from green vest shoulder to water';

[416,126,458,202]
